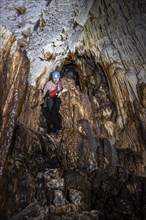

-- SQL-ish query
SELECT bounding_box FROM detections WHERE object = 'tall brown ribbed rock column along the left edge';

[0,26,29,175]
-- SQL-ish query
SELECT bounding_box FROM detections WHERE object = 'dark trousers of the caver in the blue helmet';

[46,96,61,131]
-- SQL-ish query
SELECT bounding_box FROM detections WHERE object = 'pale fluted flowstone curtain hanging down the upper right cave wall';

[81,1,146,143]
